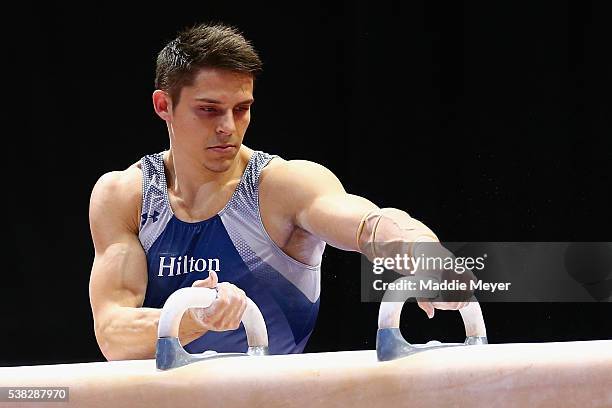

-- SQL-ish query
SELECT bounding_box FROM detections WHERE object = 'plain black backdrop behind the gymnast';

[0,1,612,365]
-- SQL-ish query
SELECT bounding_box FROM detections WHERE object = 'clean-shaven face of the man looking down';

[170,68,253,172]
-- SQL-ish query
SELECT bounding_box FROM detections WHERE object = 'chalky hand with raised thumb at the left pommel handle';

[189,271,247,331]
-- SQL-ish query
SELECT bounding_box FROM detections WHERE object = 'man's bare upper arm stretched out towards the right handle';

[282,162,378,251]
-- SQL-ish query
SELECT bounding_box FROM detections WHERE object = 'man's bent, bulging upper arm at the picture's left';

[89,174,147,326]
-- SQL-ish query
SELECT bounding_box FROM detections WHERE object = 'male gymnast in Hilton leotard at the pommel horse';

[89,23,466,360]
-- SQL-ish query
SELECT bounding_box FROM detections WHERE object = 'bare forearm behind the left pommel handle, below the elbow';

[96,307,206,360]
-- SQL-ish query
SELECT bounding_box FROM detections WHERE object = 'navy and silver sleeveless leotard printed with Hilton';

[139,151,324,354]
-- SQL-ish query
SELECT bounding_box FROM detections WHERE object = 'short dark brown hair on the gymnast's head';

[155,23,262,105]
